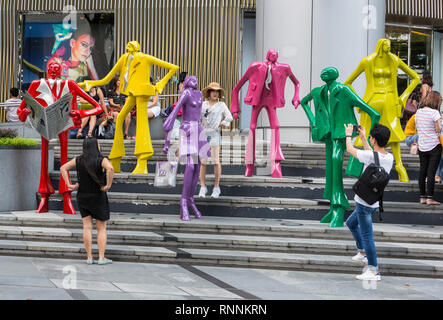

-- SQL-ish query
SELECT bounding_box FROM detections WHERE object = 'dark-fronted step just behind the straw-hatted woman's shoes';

[50,171,443,202]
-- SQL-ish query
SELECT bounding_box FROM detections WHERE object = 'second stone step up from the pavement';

[0,226,443,260]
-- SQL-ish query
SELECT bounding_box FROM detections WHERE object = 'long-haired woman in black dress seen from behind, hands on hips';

[60,138,114,265]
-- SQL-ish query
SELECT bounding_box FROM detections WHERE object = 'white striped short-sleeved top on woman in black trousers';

[415,108,441,152]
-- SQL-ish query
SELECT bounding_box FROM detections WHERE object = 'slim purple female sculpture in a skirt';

[163,76,211,221]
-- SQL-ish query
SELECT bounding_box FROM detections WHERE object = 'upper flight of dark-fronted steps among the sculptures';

[46,140,443,225]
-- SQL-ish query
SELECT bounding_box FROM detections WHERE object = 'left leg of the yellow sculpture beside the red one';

[109,96,136,173]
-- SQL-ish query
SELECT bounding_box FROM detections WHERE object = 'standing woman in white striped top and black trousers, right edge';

[415,91,442,205]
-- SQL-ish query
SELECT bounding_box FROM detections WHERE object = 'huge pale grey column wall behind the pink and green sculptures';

[256,0,386,142]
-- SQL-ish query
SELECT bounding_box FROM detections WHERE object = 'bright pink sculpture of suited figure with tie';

[231,49,300,178]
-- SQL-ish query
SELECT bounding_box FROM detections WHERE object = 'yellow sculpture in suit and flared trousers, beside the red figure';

[79,41,179,174]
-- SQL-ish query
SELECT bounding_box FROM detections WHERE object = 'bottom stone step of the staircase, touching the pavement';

[0,240,443,278]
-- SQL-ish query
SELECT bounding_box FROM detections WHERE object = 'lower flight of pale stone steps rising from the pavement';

[0,212,443,278]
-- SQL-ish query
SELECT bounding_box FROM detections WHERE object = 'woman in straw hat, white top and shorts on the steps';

[198,82,233,198]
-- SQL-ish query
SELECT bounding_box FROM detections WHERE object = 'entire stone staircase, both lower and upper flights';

[0,140,443,278]
